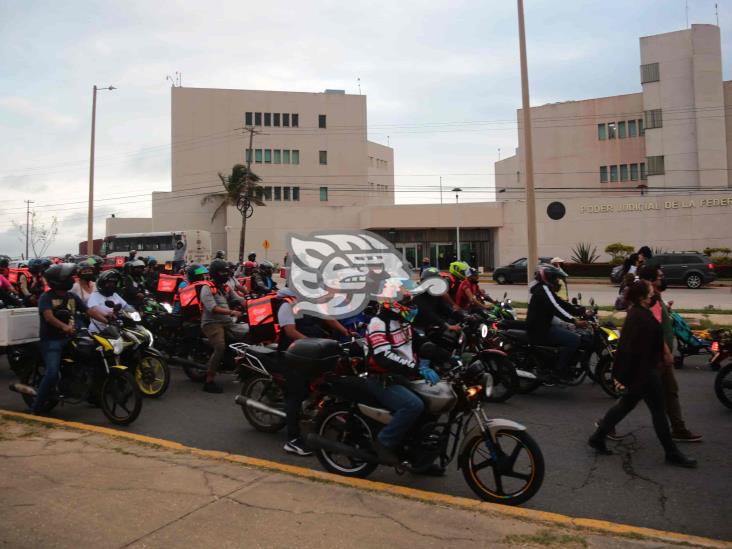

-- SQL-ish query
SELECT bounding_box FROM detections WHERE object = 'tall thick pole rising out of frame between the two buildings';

[517,0,539,281]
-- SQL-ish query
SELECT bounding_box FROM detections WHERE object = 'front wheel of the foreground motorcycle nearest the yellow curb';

[460,431,544,505]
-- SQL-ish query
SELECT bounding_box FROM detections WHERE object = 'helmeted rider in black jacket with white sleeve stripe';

[526,265,587,378]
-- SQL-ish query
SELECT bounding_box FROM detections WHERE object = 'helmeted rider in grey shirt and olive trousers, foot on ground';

[198,259,244,393]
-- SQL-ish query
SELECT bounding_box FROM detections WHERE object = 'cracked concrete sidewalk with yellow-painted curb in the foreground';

[0,415,730,548]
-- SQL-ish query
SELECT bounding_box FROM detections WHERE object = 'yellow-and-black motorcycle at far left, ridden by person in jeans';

[10,326,142,425]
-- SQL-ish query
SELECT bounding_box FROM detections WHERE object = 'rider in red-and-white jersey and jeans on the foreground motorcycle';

[366,292,440,465]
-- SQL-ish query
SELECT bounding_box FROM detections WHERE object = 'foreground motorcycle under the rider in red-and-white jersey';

[305,342,544,505]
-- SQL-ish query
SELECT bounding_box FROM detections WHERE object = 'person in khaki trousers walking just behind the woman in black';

[638,265,703,442]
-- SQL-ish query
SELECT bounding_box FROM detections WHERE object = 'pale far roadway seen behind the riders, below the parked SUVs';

[481,279,732,310]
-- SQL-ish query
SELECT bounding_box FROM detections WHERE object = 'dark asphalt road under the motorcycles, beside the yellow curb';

[0,357,732,540]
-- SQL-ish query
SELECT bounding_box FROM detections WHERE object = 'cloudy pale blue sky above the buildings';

[0,0,732,257]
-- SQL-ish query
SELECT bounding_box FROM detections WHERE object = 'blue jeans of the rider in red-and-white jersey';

[367,379,424,449]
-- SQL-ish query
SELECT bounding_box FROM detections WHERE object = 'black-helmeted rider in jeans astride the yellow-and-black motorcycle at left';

[31,263,105,414]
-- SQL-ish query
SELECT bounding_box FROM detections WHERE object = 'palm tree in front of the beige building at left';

[201,164,265,263]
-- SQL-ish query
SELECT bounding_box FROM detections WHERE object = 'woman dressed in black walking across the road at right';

[589,280,696,467]
